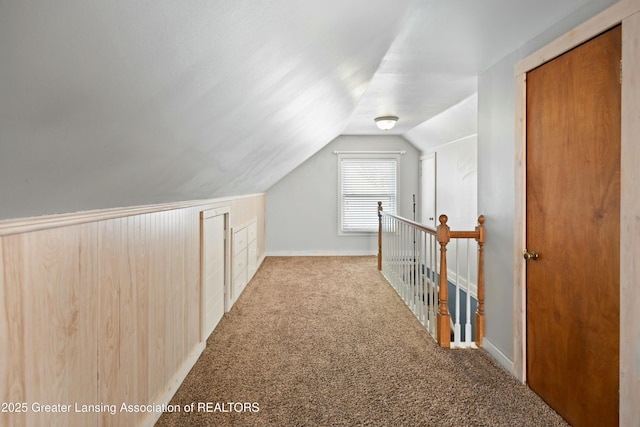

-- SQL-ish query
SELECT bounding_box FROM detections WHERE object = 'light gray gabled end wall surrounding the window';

[266,135,420,255]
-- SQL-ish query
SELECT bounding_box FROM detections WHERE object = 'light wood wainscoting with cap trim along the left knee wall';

[0,194,265,426]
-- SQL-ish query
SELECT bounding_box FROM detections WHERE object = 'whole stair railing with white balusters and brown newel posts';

[377,203,485,348]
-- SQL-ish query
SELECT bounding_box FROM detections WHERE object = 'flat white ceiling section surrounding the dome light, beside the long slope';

[344,0,600,135]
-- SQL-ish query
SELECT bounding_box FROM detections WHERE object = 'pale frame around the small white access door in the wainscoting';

[200,206,231,342]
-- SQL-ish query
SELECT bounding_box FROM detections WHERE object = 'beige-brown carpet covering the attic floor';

[156,257,566,426]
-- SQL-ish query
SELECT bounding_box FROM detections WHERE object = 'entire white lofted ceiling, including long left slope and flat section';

[0,0,604,219]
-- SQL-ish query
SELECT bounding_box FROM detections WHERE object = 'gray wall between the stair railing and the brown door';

[478,0,615,370]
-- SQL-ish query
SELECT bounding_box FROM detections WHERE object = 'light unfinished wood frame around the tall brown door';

[513,0,640,425]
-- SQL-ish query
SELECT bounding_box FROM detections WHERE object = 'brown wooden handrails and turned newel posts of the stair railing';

[378,202,485,348]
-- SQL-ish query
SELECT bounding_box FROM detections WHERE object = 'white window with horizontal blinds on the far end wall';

[338,154,399,234]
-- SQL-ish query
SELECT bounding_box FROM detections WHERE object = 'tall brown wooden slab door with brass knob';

[526,27,621,426]
